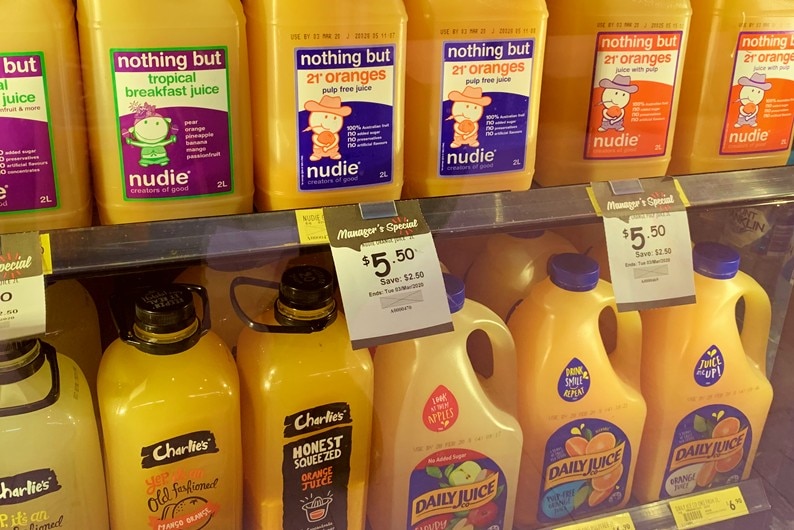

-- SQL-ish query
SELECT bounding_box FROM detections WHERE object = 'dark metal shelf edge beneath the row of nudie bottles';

[50,167,794,278]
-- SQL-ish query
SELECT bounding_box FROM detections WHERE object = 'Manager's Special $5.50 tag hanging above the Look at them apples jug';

[324,201,453,348]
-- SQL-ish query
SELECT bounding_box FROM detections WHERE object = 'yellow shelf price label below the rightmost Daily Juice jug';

[670,486,750,530]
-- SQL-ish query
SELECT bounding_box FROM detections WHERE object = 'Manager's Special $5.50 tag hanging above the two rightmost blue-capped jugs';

[588,178,695,311]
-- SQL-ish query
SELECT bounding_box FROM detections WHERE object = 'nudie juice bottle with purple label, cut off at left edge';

[0,0,91,233]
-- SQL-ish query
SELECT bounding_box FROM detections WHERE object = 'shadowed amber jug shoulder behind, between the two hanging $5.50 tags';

[466,230,576,321]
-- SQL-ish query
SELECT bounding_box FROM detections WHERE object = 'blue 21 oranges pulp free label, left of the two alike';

[295,45,396,191]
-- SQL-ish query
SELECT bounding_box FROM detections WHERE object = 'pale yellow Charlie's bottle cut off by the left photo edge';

[0,340,108,529]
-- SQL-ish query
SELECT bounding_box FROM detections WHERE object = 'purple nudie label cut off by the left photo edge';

[0,52,58,214]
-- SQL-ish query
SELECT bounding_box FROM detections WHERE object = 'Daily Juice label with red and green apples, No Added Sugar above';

[407,448,509,530]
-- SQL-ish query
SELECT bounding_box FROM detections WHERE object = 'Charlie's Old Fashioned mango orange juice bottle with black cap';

[98,285,243,530]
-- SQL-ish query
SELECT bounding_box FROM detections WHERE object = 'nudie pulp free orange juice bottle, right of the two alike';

[404,0,548,197]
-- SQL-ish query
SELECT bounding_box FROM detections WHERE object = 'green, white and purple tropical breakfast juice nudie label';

[110,46,234,200]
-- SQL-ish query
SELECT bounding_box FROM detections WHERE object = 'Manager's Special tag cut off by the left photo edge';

[0,232,47,341]
